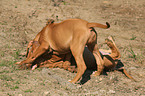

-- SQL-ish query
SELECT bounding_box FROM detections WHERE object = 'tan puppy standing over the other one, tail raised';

[20,19,110,83]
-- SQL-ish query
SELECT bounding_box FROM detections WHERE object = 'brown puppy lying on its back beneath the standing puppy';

[27,35,135,81]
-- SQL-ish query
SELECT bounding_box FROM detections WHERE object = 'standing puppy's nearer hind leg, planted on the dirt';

[67,29,90,83]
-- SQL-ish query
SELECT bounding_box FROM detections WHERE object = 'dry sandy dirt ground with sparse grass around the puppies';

[0,0,145,96]
